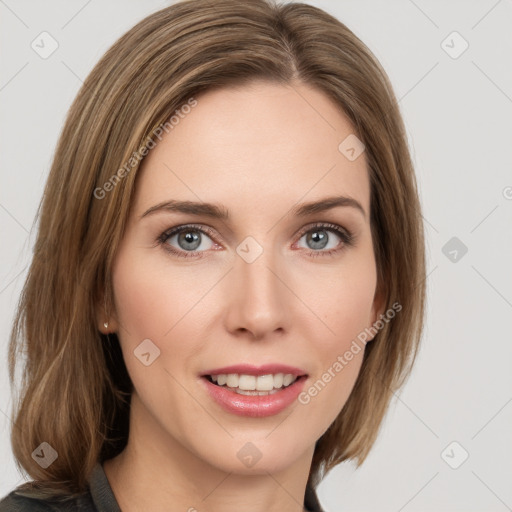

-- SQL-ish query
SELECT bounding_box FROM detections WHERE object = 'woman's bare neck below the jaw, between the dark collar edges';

[103,393,314,512]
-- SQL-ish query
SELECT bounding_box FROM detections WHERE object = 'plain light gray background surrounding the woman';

[0,0,512,512]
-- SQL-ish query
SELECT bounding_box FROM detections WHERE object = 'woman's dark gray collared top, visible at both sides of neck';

[0,463,324,512]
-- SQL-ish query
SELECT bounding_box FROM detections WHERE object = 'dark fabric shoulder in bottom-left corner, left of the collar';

[0,489,96,512]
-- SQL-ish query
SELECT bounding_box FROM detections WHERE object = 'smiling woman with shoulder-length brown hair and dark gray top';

[0,0,425,512]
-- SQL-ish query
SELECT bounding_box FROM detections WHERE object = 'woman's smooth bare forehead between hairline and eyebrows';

[136,82,369,218]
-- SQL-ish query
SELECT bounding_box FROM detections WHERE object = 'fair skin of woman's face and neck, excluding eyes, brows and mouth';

[98,81,383,512]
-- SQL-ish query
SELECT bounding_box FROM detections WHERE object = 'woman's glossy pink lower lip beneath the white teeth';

[201,375,307,418]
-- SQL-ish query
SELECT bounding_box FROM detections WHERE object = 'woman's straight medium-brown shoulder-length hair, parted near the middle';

[9,0,425,497]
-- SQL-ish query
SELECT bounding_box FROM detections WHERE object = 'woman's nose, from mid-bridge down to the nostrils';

[225,243,293,339]
